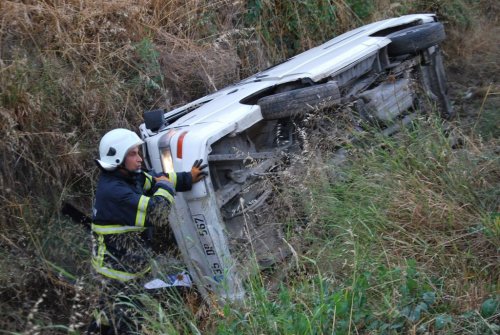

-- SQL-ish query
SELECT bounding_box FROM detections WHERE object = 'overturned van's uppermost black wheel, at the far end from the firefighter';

[387,22,446,56]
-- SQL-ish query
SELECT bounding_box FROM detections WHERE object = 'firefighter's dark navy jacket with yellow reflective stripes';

[92,170,192,281]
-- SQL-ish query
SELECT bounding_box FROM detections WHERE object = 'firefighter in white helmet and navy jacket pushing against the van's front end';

[89,128,207,333]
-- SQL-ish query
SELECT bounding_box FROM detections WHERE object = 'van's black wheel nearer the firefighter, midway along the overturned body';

[257,81,340,120]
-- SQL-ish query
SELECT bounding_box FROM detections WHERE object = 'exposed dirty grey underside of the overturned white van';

[208,36,453,268]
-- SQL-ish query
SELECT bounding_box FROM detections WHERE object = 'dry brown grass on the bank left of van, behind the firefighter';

[0,1,248,331]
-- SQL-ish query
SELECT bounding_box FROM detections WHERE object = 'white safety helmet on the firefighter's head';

[96,128,144,171]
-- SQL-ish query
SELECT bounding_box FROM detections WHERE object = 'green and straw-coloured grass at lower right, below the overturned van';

[205,119,500,334]
